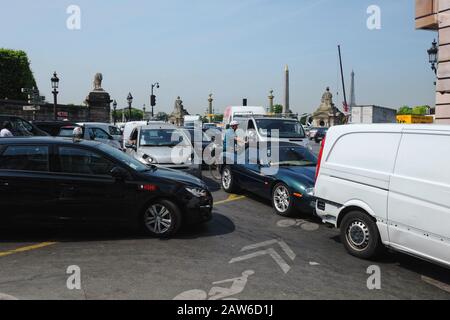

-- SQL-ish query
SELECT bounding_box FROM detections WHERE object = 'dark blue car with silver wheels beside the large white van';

[222,144,317,217]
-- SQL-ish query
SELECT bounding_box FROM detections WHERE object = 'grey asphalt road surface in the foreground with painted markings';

[0,141,450,300]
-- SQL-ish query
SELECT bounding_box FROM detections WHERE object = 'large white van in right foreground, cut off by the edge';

[315,124,450,267]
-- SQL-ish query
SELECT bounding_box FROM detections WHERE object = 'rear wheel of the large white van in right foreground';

[341,211,383,259]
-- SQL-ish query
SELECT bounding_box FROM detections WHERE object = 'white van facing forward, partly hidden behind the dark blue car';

[235,116,309,147]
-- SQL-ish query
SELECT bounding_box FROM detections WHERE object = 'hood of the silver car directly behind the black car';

[138,145,193,164]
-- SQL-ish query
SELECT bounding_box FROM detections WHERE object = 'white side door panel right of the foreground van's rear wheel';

[388,130,450,265]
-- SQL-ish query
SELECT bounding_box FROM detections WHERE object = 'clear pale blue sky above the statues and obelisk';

[0,0,436,113]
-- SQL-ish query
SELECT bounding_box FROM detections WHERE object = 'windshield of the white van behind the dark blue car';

[256,119,305,138]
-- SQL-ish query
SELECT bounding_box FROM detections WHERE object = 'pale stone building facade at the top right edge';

[416,0,450,124]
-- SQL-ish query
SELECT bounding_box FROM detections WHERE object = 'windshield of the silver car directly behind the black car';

[139,129,191,147]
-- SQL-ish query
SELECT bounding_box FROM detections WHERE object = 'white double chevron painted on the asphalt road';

[229,240,296,274]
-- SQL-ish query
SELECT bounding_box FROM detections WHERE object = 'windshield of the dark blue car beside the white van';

[271,146,317,167]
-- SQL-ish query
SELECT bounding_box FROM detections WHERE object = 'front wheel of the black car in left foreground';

[141,200,181,238]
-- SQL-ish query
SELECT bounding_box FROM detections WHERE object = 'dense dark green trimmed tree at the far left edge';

[0,48,37,100]
